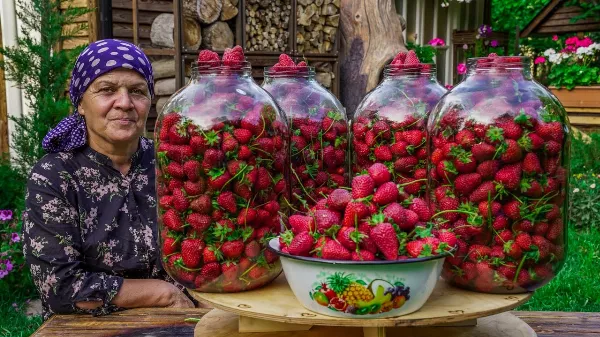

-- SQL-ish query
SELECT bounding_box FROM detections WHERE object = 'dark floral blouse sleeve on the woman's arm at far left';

[23,156,123,315]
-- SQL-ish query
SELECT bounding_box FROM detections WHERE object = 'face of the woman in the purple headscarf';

[78,69,151,146]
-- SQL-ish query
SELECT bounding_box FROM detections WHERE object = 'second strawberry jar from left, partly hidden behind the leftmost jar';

[263,54,349,211]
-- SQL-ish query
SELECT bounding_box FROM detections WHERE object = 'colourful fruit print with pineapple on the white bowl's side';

[310,272,410,315]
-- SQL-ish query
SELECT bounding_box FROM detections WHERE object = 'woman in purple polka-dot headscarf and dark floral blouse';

[23,40,193,319]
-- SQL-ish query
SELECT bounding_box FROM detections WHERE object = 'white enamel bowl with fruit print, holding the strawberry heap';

[268,238,450,319]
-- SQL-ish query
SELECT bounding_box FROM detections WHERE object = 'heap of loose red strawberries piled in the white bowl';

[279,163,457,261]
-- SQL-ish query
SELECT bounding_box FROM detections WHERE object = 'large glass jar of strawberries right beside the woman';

[155,47,289,292]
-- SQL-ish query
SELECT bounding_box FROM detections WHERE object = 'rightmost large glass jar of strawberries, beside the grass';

[428,54,571,293]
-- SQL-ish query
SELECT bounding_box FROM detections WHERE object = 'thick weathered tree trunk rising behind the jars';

[340,0,406,116]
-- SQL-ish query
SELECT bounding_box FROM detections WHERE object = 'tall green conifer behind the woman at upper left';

[0,0,92,176]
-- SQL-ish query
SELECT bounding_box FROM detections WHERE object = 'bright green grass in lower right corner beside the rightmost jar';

[517,224,600,312]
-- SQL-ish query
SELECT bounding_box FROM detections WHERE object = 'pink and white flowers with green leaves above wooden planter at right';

[536,36,600,90]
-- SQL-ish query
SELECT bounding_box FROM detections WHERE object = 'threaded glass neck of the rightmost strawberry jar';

[467,56,531,79]
